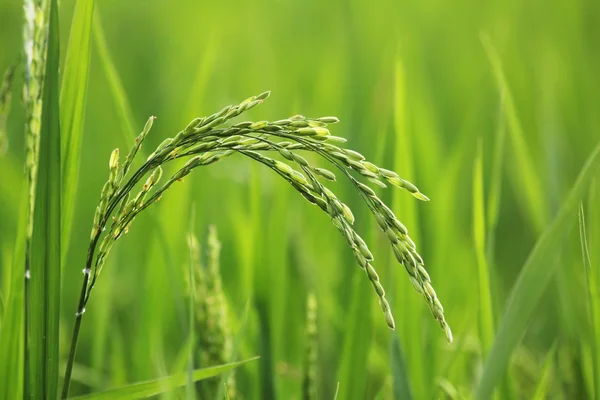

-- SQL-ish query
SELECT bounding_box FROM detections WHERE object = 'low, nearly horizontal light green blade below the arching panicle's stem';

[74,357,258,400]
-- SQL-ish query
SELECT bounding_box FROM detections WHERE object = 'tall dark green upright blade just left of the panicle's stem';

[29,0,61,399]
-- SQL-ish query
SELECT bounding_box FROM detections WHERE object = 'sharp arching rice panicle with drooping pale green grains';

[87,92,452,341]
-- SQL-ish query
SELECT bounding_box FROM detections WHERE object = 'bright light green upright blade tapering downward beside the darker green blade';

[60,0,94,260]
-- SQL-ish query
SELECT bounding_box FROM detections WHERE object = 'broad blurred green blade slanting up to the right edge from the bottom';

[475,145,600,399]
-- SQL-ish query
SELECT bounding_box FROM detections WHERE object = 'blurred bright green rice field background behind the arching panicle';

[0,0,600,399]
